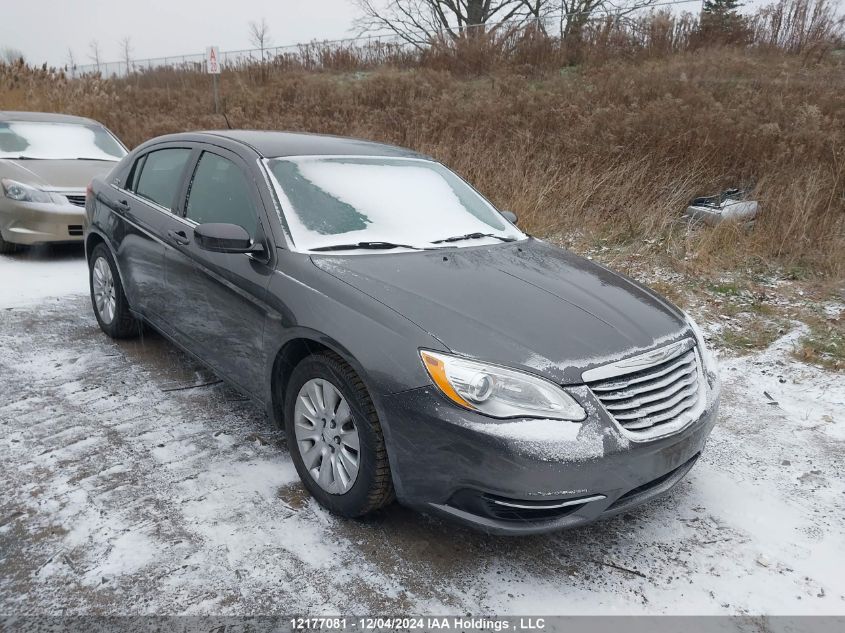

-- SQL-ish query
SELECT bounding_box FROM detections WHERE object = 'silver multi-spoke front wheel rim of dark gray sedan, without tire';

[294,378,361,495]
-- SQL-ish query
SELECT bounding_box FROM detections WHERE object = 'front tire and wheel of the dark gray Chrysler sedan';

[285,352,394,518]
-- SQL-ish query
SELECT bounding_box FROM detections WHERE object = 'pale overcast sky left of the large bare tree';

[0,0,357,65]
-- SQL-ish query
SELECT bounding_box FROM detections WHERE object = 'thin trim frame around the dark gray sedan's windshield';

[259,154,528,255]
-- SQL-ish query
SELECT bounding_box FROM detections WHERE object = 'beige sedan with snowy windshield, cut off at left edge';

[0,112,126,253]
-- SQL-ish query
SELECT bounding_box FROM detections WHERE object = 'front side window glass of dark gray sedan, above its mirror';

[185,152,258,239]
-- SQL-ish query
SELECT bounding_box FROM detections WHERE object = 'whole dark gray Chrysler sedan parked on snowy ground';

[86,131,719,534]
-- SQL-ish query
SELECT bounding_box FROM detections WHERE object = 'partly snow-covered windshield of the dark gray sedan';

[266,156,525,252]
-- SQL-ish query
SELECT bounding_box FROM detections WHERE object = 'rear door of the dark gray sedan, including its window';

[108,144,192,323]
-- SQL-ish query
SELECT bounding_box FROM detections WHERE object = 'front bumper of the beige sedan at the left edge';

[0,197,85,245]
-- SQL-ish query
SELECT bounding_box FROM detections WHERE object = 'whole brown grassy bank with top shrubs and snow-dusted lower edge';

[0,8,845,360]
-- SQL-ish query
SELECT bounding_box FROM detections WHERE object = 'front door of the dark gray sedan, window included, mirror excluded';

[165,146,275,397]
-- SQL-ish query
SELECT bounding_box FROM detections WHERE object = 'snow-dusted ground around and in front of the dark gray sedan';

[0,254,845,614]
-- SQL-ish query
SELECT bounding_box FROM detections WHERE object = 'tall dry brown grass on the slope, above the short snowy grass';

[0,48,845,277]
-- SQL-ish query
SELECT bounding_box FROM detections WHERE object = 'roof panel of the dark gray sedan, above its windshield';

[196,130,428,159]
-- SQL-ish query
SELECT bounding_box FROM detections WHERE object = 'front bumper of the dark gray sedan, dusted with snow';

[381,387,718,534]
